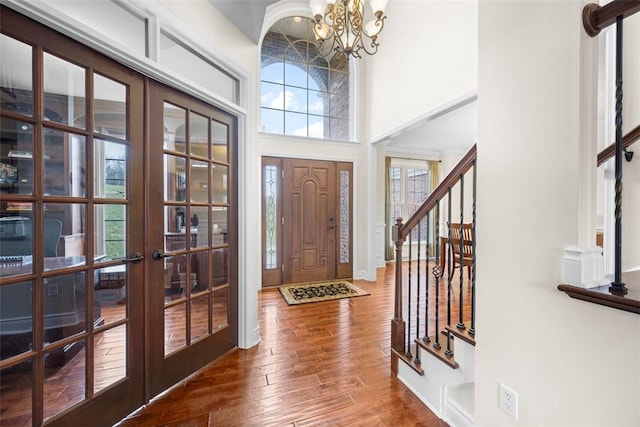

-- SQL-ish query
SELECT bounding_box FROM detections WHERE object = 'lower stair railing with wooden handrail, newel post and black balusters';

[391,145,477,373]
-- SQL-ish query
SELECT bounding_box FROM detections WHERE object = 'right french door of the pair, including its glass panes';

[147,82,238,396]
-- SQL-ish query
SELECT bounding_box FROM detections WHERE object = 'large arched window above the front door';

[260,17,350,141]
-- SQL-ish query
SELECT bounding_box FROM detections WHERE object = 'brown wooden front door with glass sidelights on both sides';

[263,157,353,286]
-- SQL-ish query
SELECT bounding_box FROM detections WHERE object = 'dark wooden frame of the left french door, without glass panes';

[0,6,145,426]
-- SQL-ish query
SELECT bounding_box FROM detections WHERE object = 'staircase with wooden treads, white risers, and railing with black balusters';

[391,145,477,426]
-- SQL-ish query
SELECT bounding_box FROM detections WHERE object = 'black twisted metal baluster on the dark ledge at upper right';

[609,15,628,294]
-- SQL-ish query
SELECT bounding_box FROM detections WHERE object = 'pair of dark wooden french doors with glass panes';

[0,5,238,426]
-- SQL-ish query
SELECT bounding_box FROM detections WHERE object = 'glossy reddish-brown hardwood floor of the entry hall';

[117,265,447,427]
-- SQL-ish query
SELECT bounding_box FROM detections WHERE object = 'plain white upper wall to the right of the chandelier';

[363,0,478,140]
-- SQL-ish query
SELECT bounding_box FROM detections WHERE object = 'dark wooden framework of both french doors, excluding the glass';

[0,5,238,426]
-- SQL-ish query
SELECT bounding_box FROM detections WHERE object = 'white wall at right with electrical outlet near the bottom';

[475,0,640,426]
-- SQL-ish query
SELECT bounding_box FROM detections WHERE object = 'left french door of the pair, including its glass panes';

[0,8,144,425]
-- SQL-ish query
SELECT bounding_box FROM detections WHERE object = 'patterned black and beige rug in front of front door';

[278,280,369,305]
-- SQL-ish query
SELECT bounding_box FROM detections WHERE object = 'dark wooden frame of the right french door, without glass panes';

[147,81,238,396]
